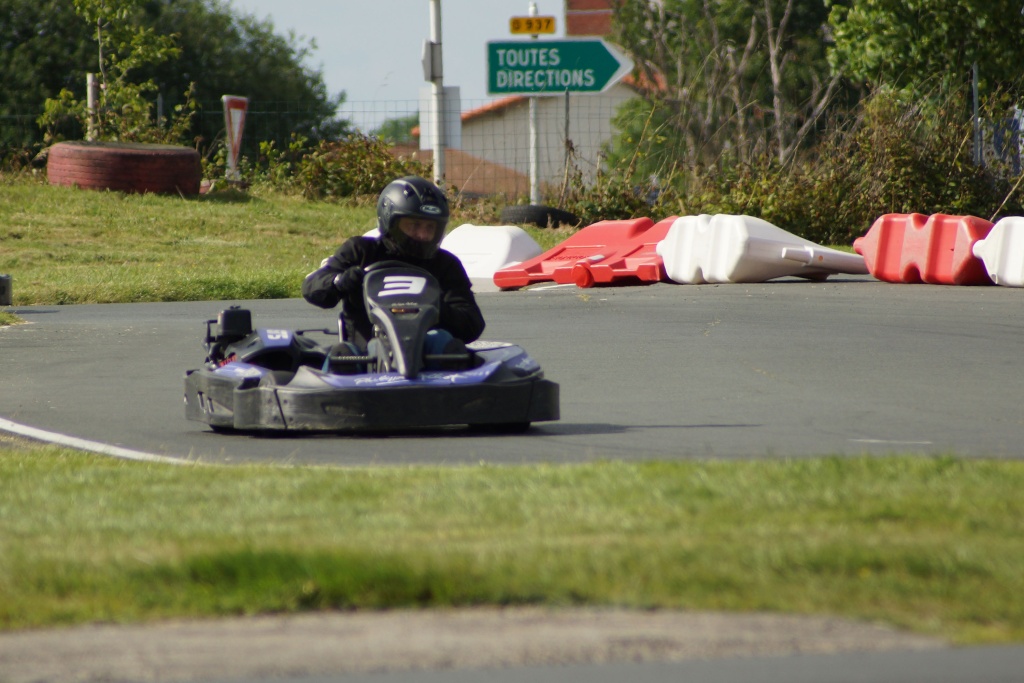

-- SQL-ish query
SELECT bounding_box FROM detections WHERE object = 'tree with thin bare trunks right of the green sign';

[613,0,841,172]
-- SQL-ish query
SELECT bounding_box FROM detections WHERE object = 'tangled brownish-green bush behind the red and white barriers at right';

[647,90,1022,245]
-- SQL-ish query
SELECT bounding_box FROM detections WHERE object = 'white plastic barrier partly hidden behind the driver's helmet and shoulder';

[441,223,542,285]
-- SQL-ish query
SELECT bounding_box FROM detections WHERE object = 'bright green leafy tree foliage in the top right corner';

[828,0,1024,92]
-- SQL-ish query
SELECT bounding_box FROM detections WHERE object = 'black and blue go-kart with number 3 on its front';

[184,261,559,432]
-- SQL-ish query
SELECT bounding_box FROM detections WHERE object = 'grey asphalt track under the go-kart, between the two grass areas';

[0,276,1024,465]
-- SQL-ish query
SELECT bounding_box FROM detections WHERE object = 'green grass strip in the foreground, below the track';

[0,449,1024,642]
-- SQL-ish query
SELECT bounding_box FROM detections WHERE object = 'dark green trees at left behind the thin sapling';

[0,0,350,157]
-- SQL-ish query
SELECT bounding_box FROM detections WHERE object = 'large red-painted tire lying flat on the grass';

[46,141,203,195]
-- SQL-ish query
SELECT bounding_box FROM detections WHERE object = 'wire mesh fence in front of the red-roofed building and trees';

[0,88,634,197]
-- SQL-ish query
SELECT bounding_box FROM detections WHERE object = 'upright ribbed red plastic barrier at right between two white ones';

[853,213,992,285]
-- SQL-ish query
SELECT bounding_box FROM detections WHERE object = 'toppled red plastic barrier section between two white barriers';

[495,216,676,289]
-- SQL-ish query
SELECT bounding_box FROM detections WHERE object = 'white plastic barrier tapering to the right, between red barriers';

[657,214,867,285]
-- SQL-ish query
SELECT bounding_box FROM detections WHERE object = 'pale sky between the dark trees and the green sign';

[224,0,565,132]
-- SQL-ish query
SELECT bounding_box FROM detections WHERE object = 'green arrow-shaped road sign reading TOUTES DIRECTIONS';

[487,39,633,95]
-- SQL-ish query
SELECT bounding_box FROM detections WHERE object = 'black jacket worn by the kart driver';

[302,237,484,348]
